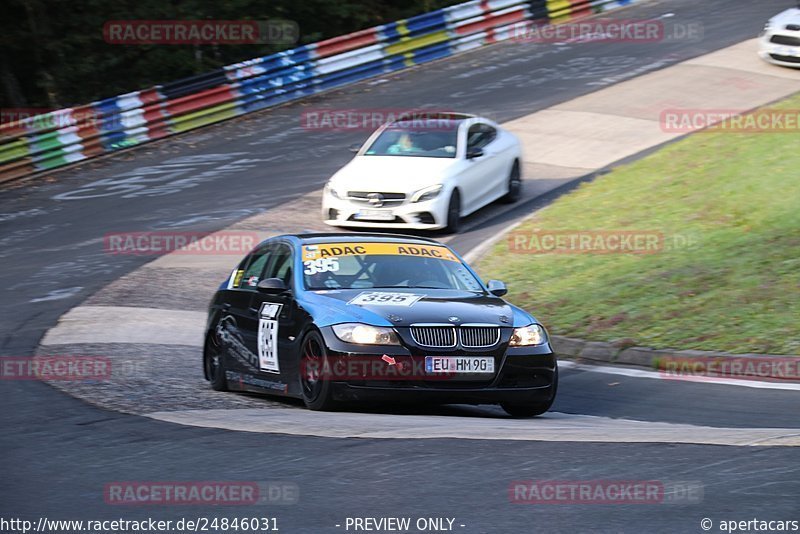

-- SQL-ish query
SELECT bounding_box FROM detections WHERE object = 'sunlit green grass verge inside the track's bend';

[478,95,800,354]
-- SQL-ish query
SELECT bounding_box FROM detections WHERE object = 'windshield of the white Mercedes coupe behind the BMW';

[364,119,461,158]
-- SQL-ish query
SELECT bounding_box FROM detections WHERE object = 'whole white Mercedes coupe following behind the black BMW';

[322,113,522,232]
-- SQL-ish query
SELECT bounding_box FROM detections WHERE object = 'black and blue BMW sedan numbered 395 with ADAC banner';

[203,233,558,417]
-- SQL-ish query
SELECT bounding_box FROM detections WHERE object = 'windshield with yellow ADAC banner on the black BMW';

[303,243,483,291]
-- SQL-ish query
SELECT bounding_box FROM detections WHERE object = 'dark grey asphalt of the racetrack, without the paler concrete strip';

[0,0,800,532]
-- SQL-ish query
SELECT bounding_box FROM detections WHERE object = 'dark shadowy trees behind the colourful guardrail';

[0,0,456,108]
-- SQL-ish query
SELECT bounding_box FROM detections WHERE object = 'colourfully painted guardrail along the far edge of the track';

[0,0,637,182]
